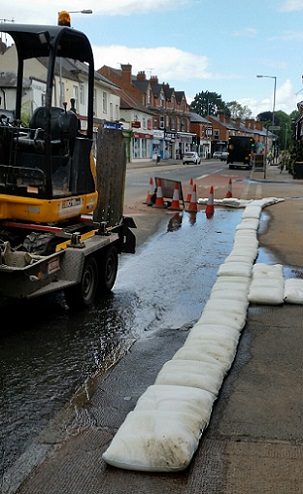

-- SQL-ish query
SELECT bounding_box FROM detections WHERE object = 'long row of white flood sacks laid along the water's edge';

[103,201,280,472]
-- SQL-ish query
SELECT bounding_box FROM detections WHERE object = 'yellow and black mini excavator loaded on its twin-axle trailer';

[0,23,136,308]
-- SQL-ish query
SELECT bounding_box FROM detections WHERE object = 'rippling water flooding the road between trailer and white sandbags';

[0,167,249,486]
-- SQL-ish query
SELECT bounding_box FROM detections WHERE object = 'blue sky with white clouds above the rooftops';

[0,0,303,118]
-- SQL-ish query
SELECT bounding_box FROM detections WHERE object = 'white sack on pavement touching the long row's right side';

[248,263,284,305]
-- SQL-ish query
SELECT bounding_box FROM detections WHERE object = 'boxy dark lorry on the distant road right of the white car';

[227,136,255,168]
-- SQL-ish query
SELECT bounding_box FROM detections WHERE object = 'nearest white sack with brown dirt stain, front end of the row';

[102,408,205,472]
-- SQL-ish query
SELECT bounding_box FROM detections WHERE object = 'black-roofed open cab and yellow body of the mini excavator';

[0,23,98,224]
